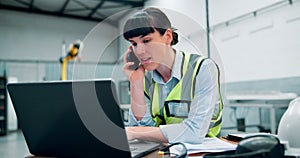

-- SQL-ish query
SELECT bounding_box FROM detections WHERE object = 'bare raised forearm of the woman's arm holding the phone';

[130,80,146,121]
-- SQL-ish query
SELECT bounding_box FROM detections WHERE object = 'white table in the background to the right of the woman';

[225,92,297,134]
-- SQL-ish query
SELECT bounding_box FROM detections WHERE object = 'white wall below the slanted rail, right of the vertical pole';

[212,1,300,82]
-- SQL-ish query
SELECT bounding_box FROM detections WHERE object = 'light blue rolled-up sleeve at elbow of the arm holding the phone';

[128,97,155,126]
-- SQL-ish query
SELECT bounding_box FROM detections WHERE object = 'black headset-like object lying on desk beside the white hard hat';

[203,135,284,158]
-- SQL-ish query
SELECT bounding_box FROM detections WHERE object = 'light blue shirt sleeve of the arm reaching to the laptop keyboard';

[159,59,218,143]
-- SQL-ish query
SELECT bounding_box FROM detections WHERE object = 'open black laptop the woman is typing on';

[7,79,162,158]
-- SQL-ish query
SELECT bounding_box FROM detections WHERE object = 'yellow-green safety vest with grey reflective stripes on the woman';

[144,52,223,137]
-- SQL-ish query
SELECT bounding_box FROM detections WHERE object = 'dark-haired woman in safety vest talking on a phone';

[123,8,223,143]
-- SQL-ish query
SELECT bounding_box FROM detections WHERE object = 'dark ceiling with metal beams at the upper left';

[0,0,147,22]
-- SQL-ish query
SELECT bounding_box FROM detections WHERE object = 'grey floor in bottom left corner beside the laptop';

[0,131,30,158]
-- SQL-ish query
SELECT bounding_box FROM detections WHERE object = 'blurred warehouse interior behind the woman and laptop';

[0,0,300,158]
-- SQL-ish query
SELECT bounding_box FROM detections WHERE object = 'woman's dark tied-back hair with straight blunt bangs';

[123,7,178,45]
